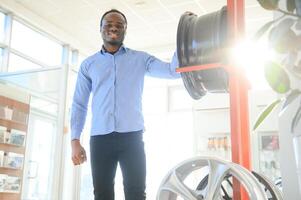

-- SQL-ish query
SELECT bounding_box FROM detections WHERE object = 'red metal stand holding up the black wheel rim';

[176,0,247,200]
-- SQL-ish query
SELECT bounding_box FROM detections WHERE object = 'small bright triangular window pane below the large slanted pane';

[8,53,42,72]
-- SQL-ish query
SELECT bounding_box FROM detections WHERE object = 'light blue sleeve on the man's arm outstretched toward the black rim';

[146,52,181,79]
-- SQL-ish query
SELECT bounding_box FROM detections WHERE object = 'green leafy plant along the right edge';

[253,0,301,133]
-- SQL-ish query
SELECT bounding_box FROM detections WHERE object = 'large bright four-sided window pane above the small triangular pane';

[11,20,63,66]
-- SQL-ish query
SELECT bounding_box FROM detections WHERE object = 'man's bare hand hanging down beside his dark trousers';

[71,139,87,165]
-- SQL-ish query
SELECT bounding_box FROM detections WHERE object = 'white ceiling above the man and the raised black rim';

[0,0,272,59]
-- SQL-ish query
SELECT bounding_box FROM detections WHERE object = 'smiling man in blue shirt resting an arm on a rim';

[71,9,180,200]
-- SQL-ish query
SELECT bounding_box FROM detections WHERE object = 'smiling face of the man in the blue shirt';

[100,12,126,46]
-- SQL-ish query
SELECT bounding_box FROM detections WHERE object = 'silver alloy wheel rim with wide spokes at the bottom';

[157,157,283,200]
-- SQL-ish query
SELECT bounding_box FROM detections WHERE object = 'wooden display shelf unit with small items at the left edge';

[0,95,30,200]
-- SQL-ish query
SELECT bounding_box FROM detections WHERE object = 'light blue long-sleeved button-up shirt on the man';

[71,46,180,139]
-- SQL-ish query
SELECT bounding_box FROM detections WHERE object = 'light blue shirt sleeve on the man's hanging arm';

[71,61,92,140]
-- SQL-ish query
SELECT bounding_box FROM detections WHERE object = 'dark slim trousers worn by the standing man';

[90,131,146,200]
